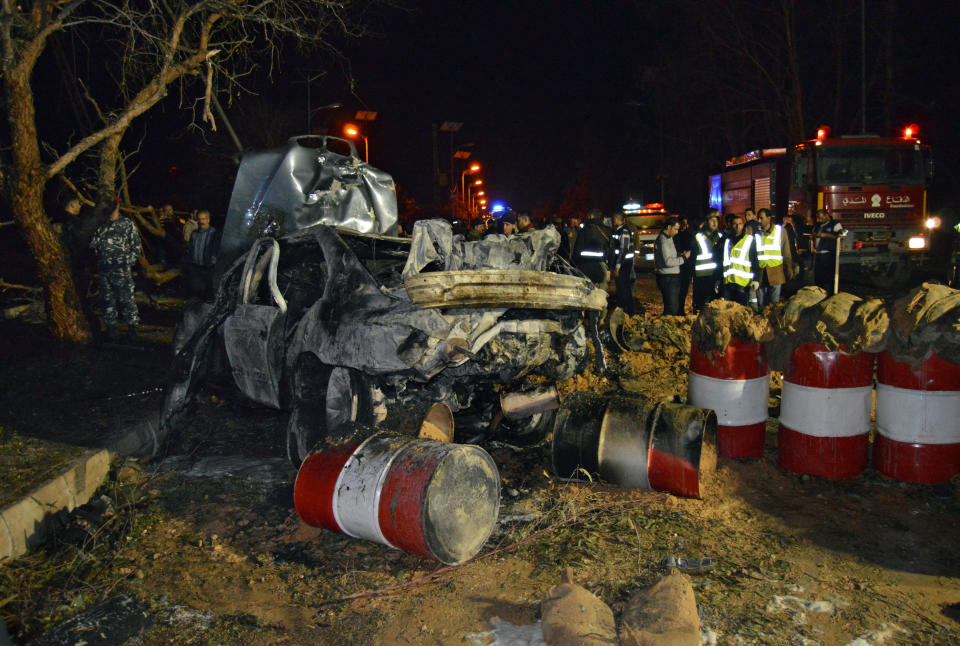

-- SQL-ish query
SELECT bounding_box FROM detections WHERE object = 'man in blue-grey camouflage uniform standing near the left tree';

[90,203,141,340]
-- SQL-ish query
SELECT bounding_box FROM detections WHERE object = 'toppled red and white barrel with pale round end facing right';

[293,433,500,565]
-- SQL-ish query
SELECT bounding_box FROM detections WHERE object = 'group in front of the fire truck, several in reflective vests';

[654,208,843,316]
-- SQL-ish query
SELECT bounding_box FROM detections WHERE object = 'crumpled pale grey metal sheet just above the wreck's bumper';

[403,220,560,279]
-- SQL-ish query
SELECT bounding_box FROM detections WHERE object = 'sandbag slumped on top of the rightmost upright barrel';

[886,283,960,364]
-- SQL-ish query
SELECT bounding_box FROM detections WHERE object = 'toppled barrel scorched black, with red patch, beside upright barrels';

[553,394,717,498]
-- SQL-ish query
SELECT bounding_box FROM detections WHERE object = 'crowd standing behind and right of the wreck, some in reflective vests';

[432,208,844,315]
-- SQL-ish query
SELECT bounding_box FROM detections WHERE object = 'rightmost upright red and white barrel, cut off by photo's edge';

[873,352,960,484]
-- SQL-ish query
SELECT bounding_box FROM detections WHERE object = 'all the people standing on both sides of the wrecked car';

[52,192,844,337]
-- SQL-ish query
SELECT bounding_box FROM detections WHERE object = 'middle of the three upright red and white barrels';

[777,343,874,478]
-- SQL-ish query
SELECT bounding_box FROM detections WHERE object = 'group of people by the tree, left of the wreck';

[55,197,220,340]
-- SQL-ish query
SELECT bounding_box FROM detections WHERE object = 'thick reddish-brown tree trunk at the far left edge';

[3,67,90,343]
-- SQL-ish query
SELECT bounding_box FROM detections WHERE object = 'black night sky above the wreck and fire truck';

[86,0,960,220]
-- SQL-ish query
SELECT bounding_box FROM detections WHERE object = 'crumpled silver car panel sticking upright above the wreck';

[216,137,397,276]
